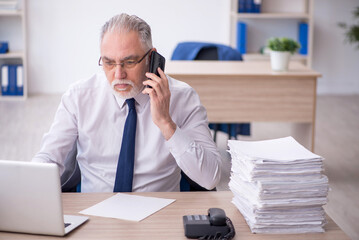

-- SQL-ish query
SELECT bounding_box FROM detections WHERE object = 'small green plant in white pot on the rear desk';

[267,37,300,71]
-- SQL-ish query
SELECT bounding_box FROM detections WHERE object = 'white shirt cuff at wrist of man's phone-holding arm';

[166,126,193,159]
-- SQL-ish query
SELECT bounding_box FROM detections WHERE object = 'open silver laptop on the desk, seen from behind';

[0,160,88,236]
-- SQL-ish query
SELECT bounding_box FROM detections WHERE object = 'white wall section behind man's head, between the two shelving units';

[27,0,229,93]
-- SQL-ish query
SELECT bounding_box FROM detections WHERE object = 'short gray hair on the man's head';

[100,13,152,49]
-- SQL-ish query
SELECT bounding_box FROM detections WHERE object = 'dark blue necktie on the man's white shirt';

[113,98,137,192]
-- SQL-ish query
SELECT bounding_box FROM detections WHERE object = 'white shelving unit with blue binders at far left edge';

[0,0,27,101]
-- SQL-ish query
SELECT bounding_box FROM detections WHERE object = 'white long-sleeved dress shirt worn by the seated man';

[33,71,221,192]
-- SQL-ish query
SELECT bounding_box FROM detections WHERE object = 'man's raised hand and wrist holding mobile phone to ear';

[142,68,176,140]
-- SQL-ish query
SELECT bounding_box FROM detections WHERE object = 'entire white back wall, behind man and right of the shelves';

[27,0,359,94]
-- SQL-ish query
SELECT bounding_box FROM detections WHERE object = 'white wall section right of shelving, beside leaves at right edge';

[313,0,359,94]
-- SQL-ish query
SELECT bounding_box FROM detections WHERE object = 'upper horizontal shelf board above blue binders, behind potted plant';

[232,13,309,20]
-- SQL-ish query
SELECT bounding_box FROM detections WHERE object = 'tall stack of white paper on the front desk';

[228,137,329,234]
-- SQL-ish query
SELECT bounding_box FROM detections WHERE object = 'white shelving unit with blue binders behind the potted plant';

[230,0,314,67]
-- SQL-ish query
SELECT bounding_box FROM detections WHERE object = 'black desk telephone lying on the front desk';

[183,208,235,240]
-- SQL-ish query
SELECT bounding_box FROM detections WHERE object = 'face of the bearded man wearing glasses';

[101,31,149,99]
